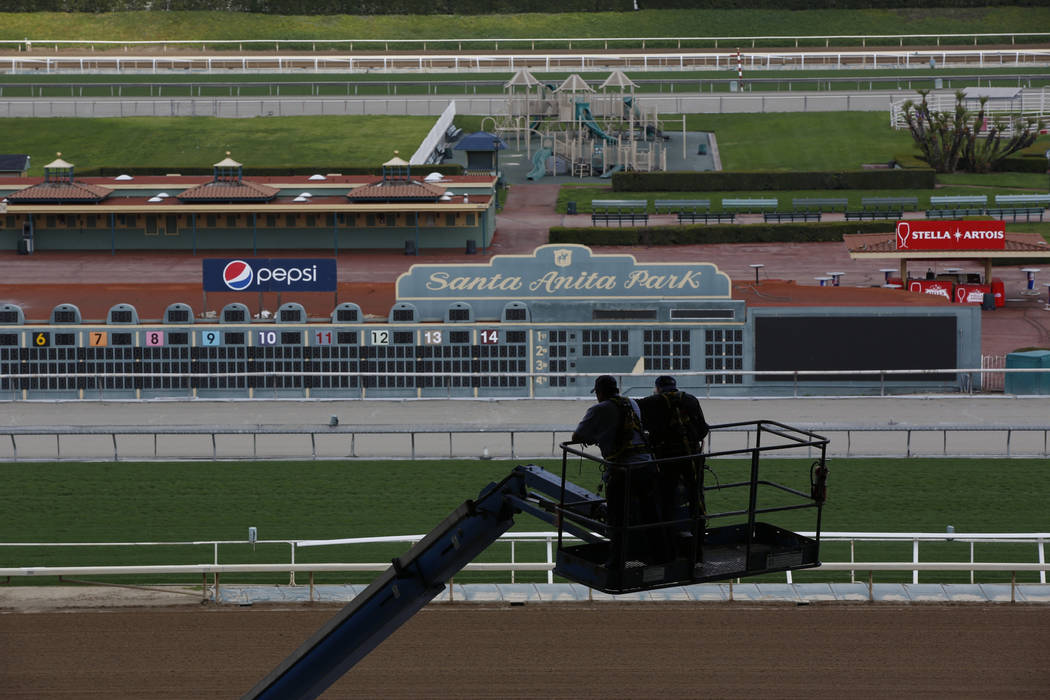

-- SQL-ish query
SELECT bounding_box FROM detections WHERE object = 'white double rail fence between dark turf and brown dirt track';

[0,532,1050,600]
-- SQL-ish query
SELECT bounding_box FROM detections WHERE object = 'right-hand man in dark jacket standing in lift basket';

[638,375,708,556]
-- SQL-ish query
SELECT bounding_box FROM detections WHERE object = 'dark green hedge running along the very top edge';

[16,0,1045,16]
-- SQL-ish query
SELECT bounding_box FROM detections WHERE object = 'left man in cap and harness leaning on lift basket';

[571,375,666,568]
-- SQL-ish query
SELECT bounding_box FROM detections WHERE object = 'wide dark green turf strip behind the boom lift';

[0,459,1047,585]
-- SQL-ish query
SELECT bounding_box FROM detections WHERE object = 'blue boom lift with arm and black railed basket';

[245,421,828,699]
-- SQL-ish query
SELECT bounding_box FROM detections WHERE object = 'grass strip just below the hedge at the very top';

[0,6,1050,49]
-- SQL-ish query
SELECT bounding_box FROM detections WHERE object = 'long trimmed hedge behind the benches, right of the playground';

[612,169,936,192]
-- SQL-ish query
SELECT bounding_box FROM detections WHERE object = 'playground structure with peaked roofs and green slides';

[482,69,667,181]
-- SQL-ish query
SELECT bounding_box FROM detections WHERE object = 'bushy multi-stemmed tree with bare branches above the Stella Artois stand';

[903,90,1045,172]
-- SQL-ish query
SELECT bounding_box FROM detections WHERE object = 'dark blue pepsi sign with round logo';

[203,258,338,292]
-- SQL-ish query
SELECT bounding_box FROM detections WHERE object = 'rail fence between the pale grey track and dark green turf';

[0,423,1050,462]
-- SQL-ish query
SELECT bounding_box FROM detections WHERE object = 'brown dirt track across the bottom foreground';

[0,603,1050,700]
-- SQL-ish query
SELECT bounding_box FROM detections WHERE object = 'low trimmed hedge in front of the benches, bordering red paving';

[550,221,894,246]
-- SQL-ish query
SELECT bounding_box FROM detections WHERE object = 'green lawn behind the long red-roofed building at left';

[0,115,434,175]
